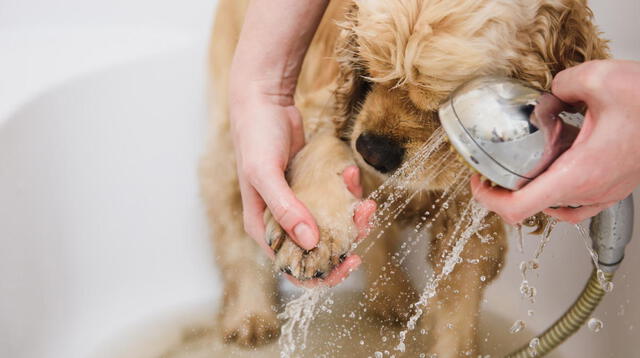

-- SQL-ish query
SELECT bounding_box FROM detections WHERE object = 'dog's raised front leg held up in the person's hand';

[265,130,357,280]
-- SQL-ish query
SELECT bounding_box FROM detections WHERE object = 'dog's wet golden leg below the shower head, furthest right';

[423,198,506,358]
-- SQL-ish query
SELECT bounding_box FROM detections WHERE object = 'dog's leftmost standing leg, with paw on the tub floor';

[200,127,280,347]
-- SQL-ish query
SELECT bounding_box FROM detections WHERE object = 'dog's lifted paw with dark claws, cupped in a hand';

[265,210,357,281]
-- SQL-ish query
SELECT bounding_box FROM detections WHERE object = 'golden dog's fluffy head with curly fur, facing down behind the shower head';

[335,0,607,189]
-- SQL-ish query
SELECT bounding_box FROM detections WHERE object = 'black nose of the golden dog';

[356,133,404,173]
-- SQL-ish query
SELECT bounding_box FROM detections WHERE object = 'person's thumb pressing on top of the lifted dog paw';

[253,168,320,250]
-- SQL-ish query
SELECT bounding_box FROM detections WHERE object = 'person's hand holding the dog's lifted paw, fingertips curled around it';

[230,81,375,287]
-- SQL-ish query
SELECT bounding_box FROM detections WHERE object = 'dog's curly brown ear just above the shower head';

[515,0,609,90]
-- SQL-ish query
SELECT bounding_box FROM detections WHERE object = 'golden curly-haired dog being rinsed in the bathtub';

[200,0,609,358]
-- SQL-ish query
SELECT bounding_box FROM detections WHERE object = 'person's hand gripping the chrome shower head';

[471,60,640,224]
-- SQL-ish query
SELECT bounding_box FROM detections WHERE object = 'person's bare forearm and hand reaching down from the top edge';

[227,0,327,256]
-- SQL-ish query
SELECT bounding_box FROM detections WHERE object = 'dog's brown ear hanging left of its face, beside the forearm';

[333,3,371,141]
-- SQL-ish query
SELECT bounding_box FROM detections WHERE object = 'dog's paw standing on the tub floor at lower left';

[222,311,280,347]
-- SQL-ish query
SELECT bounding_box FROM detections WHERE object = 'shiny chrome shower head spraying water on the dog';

[439,76,582,190]
